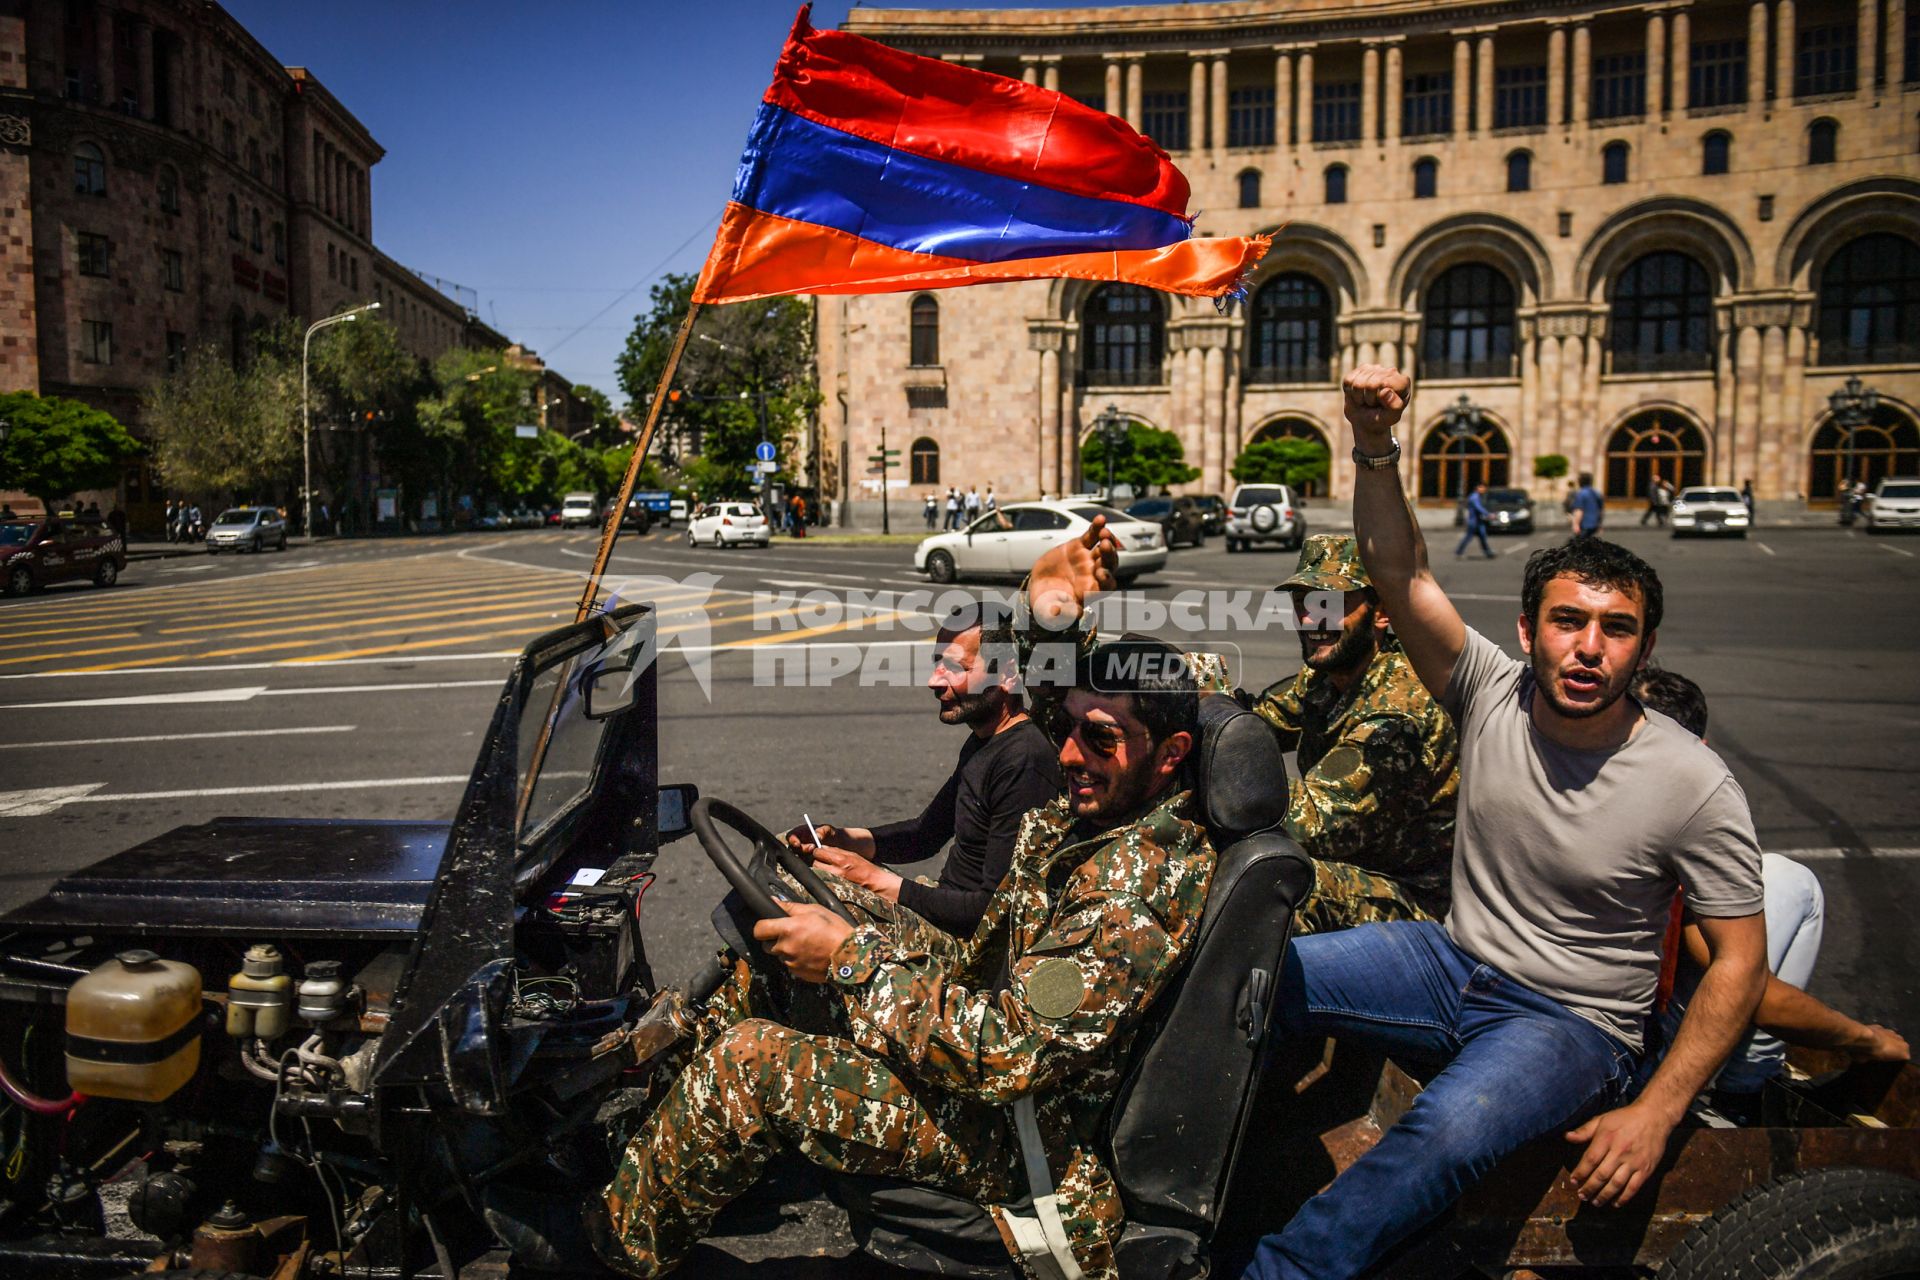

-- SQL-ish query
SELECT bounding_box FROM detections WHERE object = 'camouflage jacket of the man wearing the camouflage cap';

[1252,641,1459,919]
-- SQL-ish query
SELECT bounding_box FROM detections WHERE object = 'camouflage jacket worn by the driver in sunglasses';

[828,791,1213,1276]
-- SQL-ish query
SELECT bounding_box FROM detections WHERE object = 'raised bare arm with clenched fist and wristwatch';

[1342,365,1467,697]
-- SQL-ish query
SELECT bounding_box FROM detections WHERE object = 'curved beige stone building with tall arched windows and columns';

[818,0,1920,520]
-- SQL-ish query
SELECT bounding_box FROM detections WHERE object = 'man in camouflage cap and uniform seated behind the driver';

[1252,533,1459,933]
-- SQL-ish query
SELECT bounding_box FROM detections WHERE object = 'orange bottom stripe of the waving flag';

[693,203,1267,303]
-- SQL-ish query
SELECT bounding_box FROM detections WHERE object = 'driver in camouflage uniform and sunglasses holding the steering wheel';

[588,621,1213,1278]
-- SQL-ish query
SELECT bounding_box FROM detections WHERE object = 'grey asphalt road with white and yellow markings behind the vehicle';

[0,528,1920,1274]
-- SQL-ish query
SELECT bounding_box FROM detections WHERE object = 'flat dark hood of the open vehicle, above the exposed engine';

[0,818,451,938]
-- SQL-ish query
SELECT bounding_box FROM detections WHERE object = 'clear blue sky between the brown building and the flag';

[225,0,1121,403]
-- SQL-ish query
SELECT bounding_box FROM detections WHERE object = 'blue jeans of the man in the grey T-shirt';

[1244,921,1634,1280]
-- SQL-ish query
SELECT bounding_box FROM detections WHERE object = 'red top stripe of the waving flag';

[766,6,1188,219]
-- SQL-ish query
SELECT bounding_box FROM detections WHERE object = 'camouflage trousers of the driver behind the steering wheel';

[607,885,1020,1276]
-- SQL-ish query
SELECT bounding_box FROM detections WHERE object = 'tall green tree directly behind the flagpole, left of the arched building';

[618,274,820,474]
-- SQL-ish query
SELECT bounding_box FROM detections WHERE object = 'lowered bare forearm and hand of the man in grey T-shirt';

[1567,912,1766,1205]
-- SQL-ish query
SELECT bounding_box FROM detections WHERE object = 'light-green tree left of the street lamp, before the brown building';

[144,347,300,503]
